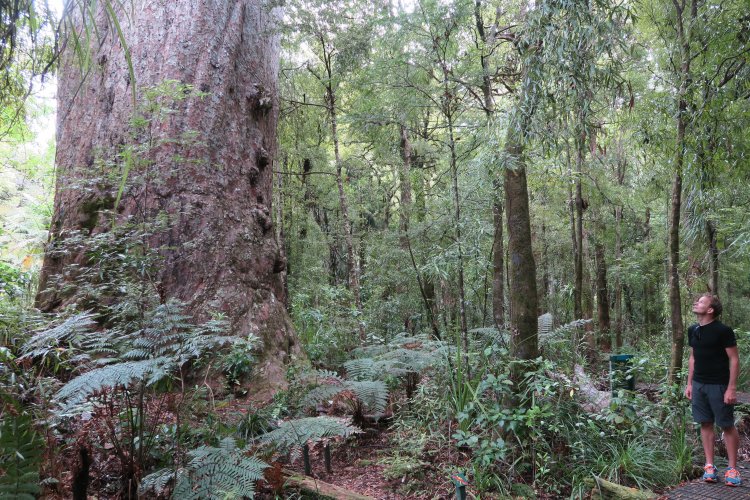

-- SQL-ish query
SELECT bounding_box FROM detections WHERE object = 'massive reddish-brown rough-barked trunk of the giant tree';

[37,0,298,386]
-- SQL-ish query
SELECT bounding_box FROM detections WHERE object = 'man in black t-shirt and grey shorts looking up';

[685,294,742,486]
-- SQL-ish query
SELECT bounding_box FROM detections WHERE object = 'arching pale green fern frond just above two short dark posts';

[260,417,362,457]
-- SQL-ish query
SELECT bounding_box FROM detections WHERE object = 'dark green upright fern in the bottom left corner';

[0,414,43,500]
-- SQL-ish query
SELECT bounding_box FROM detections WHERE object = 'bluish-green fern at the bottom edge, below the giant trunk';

[139,437,268,500]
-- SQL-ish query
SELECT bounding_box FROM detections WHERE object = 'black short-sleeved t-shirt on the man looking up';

[688,320,737,385]
